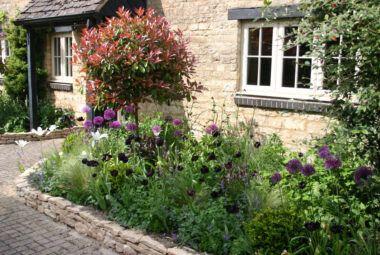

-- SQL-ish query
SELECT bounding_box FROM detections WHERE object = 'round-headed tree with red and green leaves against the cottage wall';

[73,8,201,127]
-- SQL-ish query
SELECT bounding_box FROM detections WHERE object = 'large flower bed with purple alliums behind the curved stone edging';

[28,110,379,254]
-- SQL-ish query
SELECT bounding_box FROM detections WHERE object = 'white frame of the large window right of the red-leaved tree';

[237,21,331,101]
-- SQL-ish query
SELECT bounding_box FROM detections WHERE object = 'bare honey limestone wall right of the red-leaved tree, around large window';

[144,0,326,148]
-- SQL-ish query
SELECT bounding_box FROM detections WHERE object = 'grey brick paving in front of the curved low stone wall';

[0,139,116,255]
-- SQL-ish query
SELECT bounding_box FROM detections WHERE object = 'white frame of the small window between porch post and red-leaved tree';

[51,33,74,83]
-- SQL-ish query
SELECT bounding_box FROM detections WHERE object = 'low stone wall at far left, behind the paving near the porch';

[0,127,83,144]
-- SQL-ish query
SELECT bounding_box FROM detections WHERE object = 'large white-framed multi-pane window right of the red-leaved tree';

[239,22,328,100]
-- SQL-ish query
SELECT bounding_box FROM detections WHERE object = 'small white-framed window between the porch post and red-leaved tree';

[52,34,73,81]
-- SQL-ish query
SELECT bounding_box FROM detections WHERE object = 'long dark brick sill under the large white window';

[234,95,330,113]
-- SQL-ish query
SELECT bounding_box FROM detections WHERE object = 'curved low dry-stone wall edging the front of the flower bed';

[15,167,205,255]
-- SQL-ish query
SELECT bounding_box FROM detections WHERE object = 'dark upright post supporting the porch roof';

[26,28,38,130]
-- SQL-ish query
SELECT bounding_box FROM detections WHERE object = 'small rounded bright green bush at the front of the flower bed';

[244,208,303,254]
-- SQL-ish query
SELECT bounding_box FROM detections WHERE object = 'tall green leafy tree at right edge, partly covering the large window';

[297,0,380,170]
